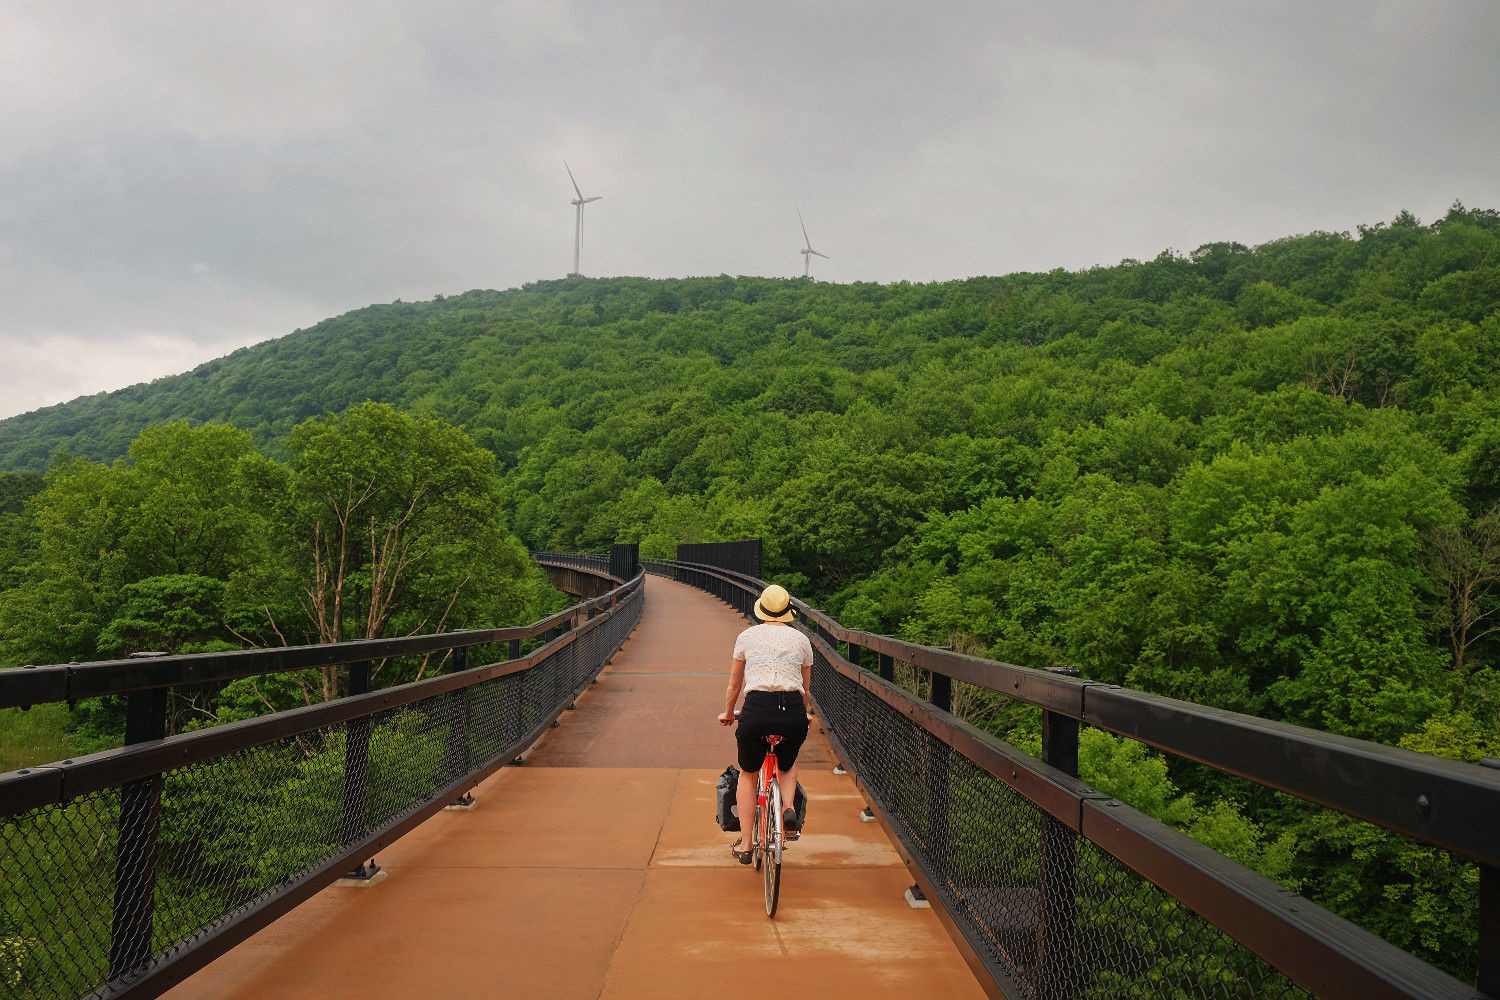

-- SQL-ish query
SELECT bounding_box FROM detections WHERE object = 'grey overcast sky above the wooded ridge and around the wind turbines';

[0,0,1500,417]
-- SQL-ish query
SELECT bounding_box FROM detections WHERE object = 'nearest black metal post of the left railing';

[110,652,167,979]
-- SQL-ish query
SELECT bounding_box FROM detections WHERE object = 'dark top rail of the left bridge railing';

[0,563,641,708]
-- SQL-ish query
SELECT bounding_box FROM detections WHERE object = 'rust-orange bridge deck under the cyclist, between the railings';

[167,577,984,1000]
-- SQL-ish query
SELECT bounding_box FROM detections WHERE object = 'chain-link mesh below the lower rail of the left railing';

[0,594,642,1000]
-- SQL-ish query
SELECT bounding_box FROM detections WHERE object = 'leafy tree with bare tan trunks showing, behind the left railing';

[288,403,539,642]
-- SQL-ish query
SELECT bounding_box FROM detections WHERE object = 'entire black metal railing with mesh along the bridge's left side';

[0,562,644,1000]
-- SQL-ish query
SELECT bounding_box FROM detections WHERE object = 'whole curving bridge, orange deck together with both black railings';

[0,546,1500,1000]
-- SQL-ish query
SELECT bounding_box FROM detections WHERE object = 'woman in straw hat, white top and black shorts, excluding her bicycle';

[719,583,813,865]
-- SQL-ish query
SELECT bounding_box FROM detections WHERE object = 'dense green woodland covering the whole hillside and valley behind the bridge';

[0,204,1500,976]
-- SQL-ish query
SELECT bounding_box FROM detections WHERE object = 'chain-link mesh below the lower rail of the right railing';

[813,649,1307,1000]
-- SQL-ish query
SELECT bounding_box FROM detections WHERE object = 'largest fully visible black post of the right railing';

[1037,667,1079,1000]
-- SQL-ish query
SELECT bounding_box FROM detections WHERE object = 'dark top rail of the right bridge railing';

[660,561,1500,865]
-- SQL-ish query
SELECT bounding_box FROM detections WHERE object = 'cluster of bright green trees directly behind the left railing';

[0,403,554,746]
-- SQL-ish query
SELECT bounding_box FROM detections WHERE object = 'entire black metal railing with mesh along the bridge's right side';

[657,561,1500,1000]
